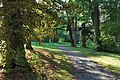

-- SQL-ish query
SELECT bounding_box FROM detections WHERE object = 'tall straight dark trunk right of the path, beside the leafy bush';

[93,1,100,45]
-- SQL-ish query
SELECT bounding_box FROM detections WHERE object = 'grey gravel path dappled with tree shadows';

[59,46,117,80]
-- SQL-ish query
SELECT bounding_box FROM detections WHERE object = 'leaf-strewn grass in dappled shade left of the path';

[28,42,73,80]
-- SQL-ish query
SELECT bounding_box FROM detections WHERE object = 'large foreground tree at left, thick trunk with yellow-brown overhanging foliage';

[0,0,62,68]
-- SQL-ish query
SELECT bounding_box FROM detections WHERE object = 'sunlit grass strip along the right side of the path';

[68,47,120,77]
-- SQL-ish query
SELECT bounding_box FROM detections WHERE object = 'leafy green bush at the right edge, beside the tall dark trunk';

[97,22,120,52]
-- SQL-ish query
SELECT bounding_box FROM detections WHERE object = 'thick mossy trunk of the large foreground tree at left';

[3,0,27,69]
